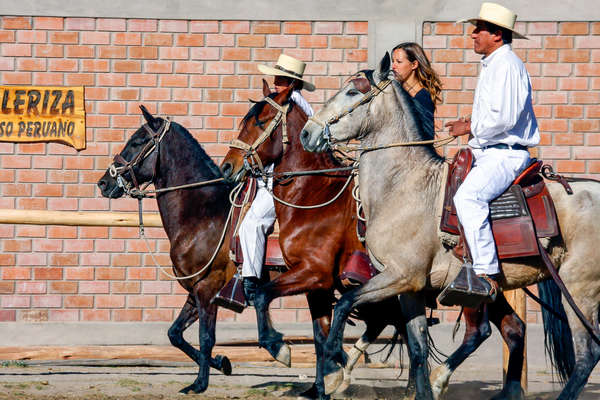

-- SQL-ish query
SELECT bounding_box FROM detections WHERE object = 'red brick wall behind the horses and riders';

[0,17,600,322]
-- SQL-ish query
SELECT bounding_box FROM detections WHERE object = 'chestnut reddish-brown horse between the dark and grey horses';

[221,81,431,398]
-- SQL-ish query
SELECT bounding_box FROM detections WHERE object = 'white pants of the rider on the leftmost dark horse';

[239,179,275,278]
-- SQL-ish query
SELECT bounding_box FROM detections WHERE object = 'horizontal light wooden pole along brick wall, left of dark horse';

[0,209,162,228]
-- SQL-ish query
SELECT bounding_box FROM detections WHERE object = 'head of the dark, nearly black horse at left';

[98,105,169,199]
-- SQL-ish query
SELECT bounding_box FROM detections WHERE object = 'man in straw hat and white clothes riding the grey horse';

[446,3,540,302]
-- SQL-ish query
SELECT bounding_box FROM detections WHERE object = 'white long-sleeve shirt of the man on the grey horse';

[469,44,540,148]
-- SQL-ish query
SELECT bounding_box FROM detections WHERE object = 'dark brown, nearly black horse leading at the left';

[98,108,235,393]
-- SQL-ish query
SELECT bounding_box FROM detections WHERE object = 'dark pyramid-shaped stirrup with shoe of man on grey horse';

[438,263,499,308]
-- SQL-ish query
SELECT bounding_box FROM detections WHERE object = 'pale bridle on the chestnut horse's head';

[229,97,290,176]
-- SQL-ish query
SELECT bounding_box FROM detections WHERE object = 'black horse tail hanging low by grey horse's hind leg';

[538,279,575,383]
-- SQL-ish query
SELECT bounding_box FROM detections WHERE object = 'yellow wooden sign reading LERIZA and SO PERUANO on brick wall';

[0,86,85,150]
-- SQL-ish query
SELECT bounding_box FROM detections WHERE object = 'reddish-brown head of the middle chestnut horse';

[221,83,292,182]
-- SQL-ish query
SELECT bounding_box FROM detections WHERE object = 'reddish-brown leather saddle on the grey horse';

[440,148,560,259]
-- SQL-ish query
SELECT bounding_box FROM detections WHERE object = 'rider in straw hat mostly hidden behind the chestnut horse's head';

[239,54,315,305]
